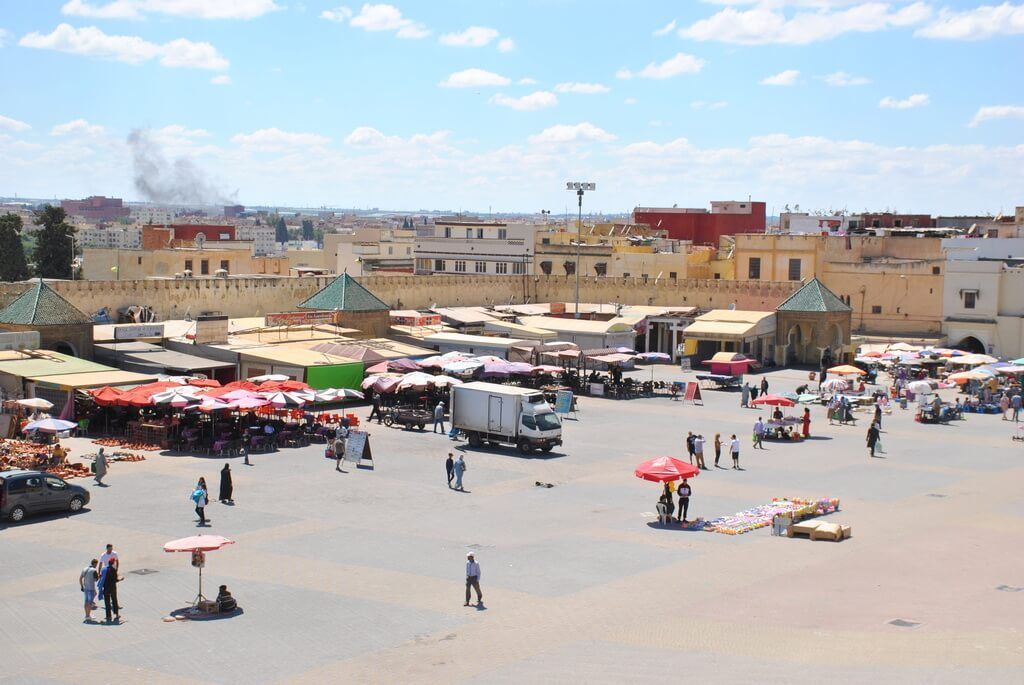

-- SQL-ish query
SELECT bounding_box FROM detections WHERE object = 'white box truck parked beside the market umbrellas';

[452,383,562,455]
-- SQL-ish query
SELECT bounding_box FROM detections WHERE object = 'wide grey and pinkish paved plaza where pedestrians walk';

[0,367,1024,685]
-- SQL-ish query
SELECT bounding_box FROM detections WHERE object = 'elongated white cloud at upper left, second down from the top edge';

[18,24,229,71]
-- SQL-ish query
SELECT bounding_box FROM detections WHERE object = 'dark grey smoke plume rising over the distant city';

[128,129,234,205]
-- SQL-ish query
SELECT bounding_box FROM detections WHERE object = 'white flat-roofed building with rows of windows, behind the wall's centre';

[414,220,538,275]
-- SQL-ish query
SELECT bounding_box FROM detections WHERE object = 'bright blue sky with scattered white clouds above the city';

[0,0,1024,214]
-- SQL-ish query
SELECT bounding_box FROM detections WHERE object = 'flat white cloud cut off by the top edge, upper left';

[60,0,283,19]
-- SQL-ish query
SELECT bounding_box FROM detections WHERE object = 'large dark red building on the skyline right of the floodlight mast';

[633,201,766,245]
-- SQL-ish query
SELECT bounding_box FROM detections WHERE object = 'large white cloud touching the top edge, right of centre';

[679,2,932,45]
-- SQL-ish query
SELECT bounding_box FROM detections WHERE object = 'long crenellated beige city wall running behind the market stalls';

[0,275,800,319]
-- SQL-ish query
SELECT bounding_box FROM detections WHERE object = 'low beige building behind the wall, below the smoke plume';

[82,241,288,281]
